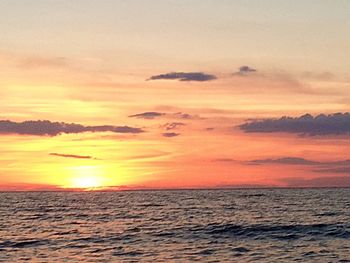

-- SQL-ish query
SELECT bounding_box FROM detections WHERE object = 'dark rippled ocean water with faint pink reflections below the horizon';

[0,189,350,262]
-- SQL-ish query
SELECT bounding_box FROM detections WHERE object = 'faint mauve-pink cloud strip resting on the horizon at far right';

[280,176,350,187]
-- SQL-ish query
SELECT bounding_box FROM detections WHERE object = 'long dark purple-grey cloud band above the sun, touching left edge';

[0,120,144,136]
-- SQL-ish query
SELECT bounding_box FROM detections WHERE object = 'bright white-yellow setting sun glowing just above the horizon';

[69,166,106,190]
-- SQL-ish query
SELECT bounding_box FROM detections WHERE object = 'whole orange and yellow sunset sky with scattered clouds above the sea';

[0,0,350,191]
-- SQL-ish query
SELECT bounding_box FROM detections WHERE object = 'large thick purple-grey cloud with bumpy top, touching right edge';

[239,112,350,136]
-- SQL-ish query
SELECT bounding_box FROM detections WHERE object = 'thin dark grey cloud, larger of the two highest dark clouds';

[148,72,217,81]
